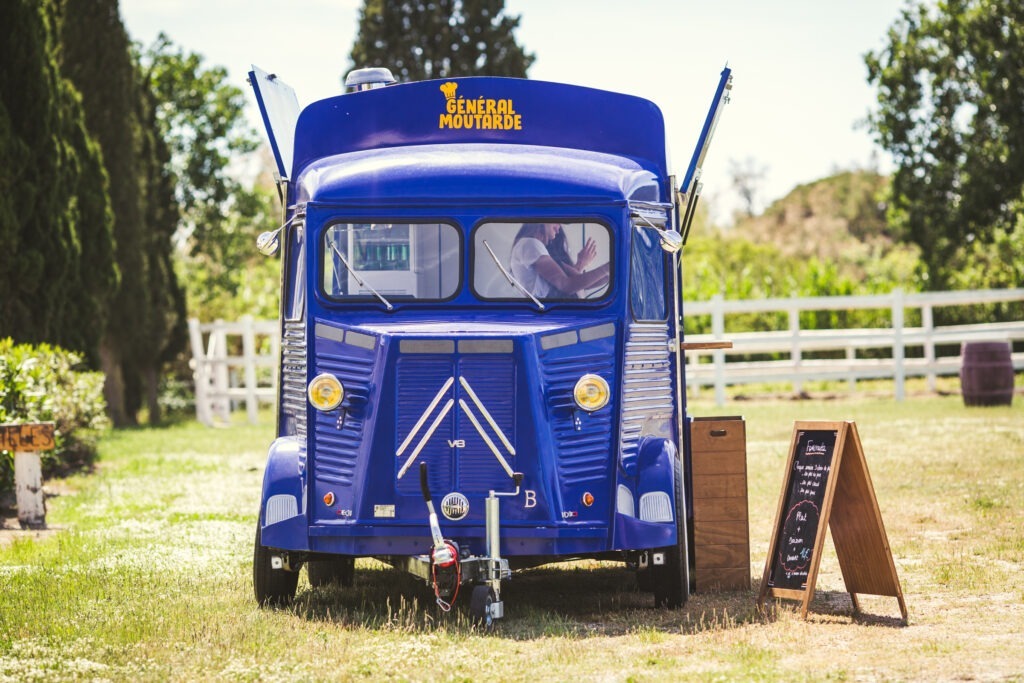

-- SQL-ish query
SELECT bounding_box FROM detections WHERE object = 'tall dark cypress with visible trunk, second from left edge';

[59,0,184,424]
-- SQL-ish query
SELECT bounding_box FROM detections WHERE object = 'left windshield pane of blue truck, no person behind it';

[323,223,462,301]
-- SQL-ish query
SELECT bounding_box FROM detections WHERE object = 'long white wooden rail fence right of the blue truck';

[683,289,1024,405]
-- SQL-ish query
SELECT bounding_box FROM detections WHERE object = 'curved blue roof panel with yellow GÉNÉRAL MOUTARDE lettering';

[291,78,668,184]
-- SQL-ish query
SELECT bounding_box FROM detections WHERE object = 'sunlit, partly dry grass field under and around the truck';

[0,397,1024,681]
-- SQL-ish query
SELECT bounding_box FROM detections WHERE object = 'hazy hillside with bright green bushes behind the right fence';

[683,171,921,333]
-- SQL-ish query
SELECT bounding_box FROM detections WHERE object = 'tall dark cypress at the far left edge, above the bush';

[0,0,118,361]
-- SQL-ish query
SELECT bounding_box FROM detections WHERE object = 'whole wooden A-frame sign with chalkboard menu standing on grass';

[758,422,907,623]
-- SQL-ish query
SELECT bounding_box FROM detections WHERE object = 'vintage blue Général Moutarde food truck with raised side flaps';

[250,63,731,624]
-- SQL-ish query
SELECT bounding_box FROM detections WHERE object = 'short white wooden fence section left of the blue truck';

[188,315,281,427]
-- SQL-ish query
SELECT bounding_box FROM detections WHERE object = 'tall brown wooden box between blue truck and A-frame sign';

[690,418,751,592]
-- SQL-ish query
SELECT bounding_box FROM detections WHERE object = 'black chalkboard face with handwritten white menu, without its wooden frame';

[768,430,839,590]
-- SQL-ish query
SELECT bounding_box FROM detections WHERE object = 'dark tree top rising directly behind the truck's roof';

[349,0,534,81]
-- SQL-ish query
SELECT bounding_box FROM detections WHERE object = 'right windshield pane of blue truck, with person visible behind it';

[472,221,612,301]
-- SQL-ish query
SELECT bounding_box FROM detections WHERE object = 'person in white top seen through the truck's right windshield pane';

[512,223,609,299]
